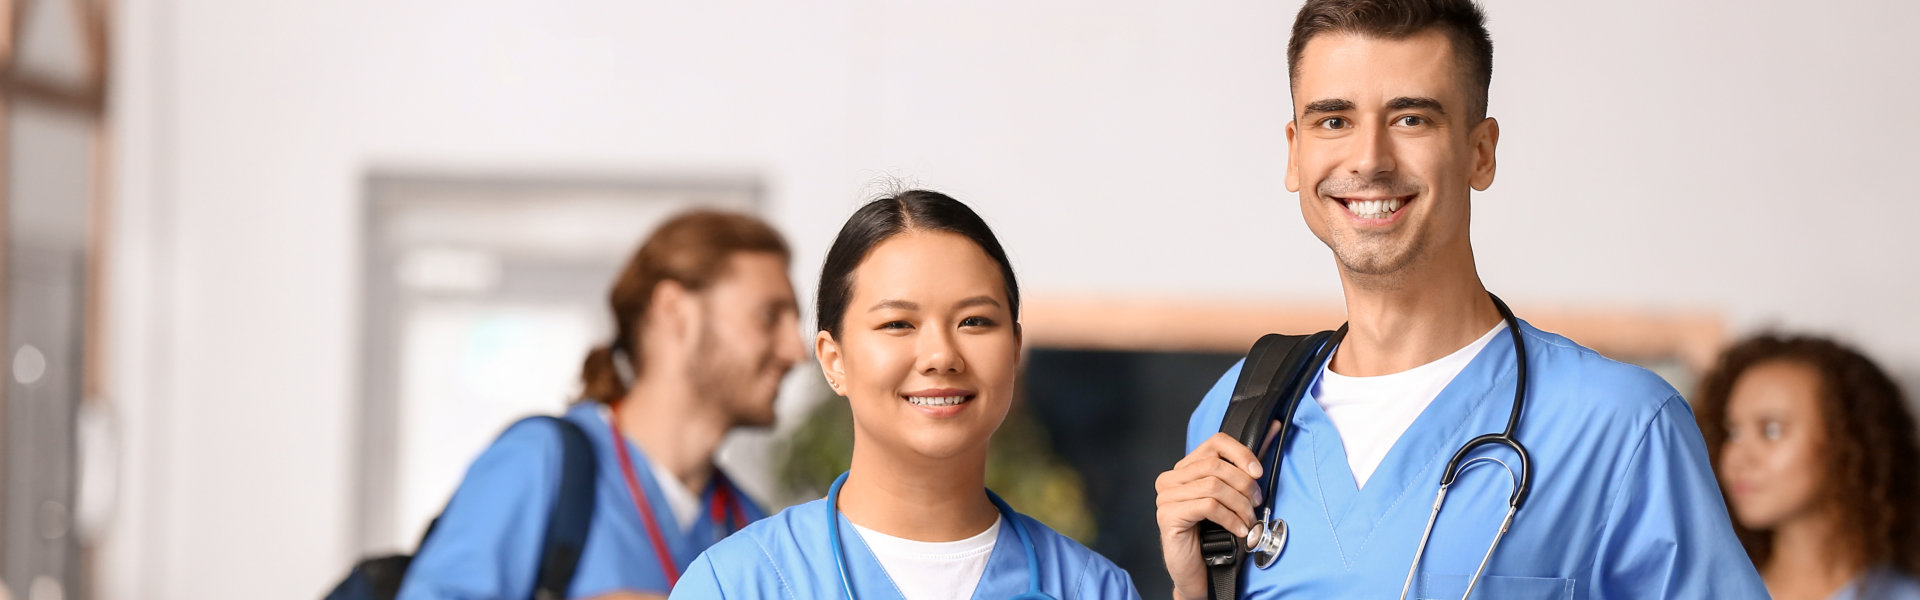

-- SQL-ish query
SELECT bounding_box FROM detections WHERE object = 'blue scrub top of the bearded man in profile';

[399,402,766,600]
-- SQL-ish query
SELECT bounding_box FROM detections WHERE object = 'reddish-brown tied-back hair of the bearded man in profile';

[580,210,789,404]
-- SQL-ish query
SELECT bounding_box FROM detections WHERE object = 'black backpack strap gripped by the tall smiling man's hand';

[1200,329,1346,600]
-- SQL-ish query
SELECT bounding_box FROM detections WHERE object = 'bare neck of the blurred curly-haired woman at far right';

[1761,513,1866,600]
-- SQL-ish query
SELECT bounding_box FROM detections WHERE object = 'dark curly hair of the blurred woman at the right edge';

[1693,335,1920,573]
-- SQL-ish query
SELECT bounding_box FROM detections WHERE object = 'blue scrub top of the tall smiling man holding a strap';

[1187,321,1766,600]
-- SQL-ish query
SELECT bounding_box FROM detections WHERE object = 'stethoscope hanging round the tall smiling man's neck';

[1246,294,1534,600]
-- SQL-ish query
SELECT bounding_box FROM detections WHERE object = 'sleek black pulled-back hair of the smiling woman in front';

[816,190,1020,338]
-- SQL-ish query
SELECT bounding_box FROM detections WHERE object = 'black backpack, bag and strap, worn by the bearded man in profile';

[326,415,597,600]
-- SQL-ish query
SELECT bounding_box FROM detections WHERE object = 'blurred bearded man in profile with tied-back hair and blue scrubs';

[399,212,804,600]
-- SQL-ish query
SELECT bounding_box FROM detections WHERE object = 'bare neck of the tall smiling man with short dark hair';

[1331,258,1500,377]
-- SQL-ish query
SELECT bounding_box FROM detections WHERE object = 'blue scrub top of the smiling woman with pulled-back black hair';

[672,500,1140,600]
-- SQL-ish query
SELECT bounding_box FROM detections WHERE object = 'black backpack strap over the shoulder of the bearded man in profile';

[530,417,599,600]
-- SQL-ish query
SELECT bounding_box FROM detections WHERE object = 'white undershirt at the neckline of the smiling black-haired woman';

[852,519,1002,600]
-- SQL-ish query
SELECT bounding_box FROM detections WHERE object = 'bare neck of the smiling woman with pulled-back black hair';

[839,438,1000,542]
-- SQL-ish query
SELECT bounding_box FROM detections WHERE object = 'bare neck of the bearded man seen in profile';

[614,377,733,494]
